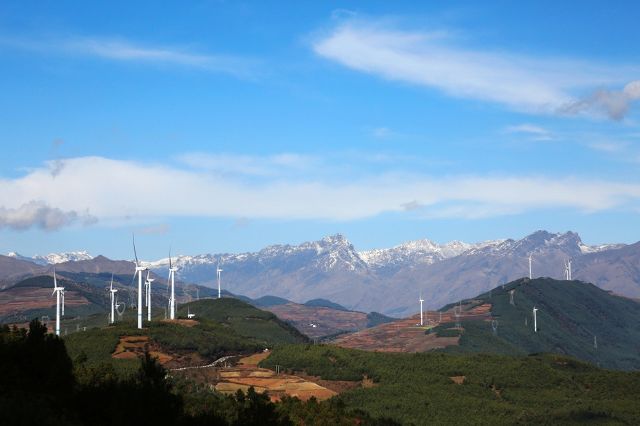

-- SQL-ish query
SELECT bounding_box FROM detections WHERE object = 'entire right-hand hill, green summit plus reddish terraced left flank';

[336,278,640,370]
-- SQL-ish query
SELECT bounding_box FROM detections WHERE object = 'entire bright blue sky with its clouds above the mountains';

[0,1,640,259]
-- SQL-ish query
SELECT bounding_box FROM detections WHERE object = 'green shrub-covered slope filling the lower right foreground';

[262,345,640,424]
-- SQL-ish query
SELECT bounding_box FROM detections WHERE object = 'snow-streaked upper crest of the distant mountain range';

[144,231,621,275]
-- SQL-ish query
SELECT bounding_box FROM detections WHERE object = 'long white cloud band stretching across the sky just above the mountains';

[0,157,640,227]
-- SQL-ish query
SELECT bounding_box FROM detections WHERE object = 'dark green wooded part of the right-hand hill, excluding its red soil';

[435,278,640,370]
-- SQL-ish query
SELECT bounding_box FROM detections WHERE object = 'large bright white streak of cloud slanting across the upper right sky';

[313,19,639,118]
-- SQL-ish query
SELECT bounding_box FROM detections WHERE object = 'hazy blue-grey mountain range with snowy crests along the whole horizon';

[5,231,640,316]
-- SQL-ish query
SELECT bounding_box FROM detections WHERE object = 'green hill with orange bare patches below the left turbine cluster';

[64,298,308,369]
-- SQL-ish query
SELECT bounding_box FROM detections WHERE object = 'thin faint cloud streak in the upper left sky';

[0,37,256,75]
